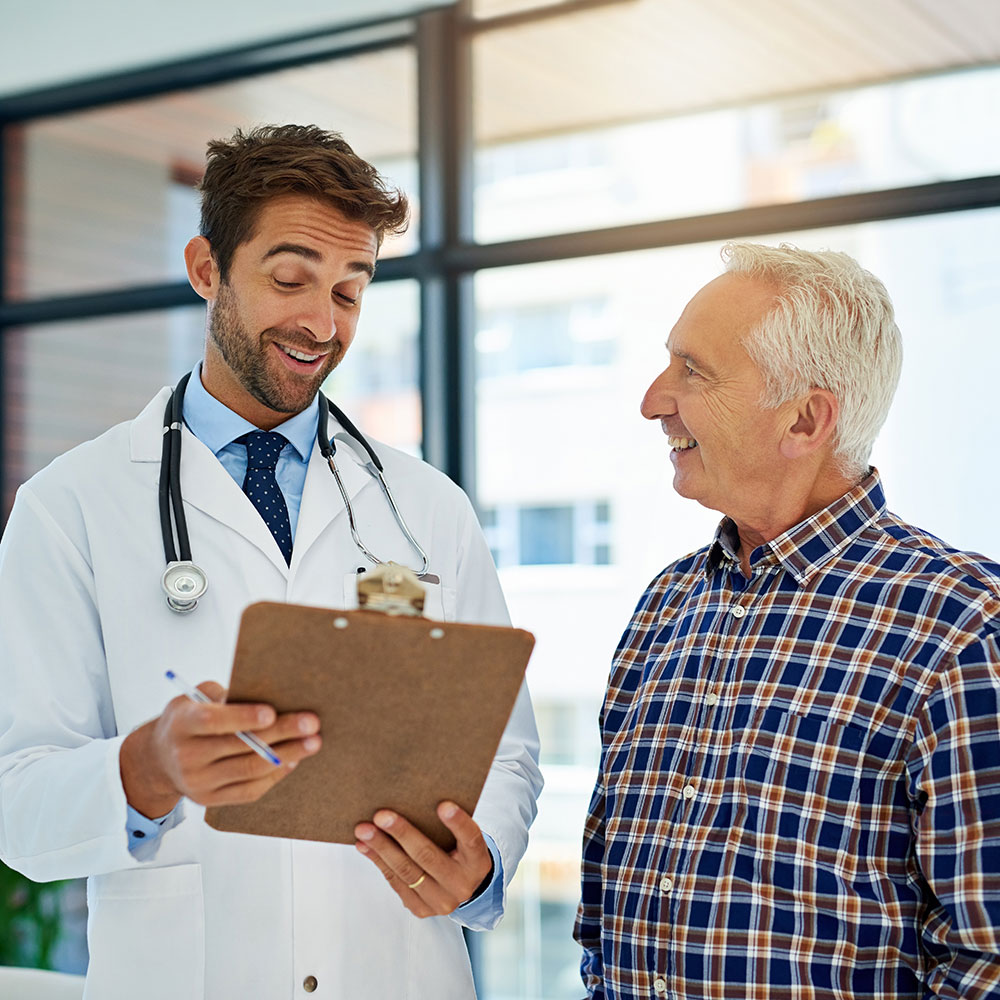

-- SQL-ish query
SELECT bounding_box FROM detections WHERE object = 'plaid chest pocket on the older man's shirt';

[734,707,910,880]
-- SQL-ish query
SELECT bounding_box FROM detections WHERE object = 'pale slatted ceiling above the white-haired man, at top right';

[474,0,1000,141]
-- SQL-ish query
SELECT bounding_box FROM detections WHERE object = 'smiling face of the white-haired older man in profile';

[642,274,796,524]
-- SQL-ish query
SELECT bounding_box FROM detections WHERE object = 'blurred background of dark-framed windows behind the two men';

[0,0,1000,1000]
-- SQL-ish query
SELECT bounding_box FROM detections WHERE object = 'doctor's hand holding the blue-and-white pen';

[118,681,321,818]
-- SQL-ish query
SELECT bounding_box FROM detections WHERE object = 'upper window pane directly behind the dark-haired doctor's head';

[6,47,417,300]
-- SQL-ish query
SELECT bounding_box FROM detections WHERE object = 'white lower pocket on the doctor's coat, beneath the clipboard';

[84,865,205,1000]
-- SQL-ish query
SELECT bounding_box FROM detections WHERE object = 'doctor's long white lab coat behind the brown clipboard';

[0,389,541,1000]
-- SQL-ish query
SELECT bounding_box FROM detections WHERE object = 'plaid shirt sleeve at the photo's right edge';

[908,634,1000,1000]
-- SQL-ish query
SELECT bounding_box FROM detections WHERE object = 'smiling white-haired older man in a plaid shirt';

[576,244,1000,1000]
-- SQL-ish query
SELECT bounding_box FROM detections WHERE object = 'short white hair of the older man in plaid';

[722,243,903,480]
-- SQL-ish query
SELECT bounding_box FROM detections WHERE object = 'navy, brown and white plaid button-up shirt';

[575,471,1000,1000]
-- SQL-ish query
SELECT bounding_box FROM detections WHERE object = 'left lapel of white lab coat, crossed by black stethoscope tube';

[130,388,290,575]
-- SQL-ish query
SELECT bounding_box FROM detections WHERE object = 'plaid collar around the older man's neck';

[705,468,886,587]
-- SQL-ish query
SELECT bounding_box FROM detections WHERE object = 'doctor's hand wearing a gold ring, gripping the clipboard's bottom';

[354,802,493,917]
